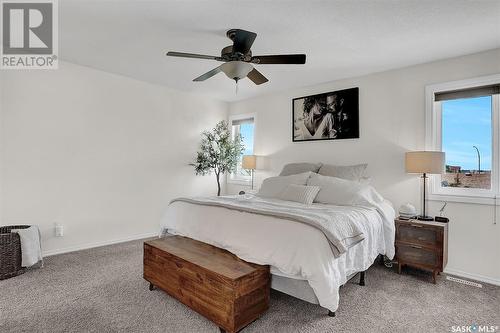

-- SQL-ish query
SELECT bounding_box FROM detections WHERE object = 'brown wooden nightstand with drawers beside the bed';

[395,219,448,283]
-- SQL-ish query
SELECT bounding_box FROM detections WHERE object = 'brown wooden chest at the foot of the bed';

[144,236,271,333]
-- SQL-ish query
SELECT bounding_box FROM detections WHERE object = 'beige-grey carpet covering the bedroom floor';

[0,237,500,333]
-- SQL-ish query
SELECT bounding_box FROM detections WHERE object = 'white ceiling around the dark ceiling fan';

[59,0,500,101]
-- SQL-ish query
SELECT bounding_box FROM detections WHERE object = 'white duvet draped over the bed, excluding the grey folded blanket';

[161,195,394,311]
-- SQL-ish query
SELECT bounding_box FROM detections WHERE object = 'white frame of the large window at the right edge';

[425,74,500,205]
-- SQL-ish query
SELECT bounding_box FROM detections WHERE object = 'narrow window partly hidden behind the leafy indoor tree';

[228,115,255,184]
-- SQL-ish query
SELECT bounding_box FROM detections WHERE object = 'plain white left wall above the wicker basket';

[0,62,227,253]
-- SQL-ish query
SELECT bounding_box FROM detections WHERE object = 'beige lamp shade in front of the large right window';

[406,151,444,174]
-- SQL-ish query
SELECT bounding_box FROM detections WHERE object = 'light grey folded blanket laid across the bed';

[171,196,364,258]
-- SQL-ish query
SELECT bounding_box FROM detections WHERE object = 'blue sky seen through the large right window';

[442,96,492,170]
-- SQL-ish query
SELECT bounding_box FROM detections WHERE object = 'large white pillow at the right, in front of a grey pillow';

[307,174,384,207]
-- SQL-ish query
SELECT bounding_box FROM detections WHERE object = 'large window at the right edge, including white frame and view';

[426,75,500,204]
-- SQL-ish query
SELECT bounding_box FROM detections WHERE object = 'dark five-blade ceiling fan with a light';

[167,29,306,85]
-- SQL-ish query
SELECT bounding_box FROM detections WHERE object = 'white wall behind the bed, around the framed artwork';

[228,49,500,284]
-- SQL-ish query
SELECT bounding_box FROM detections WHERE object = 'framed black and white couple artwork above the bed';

[292,88,359,142]
